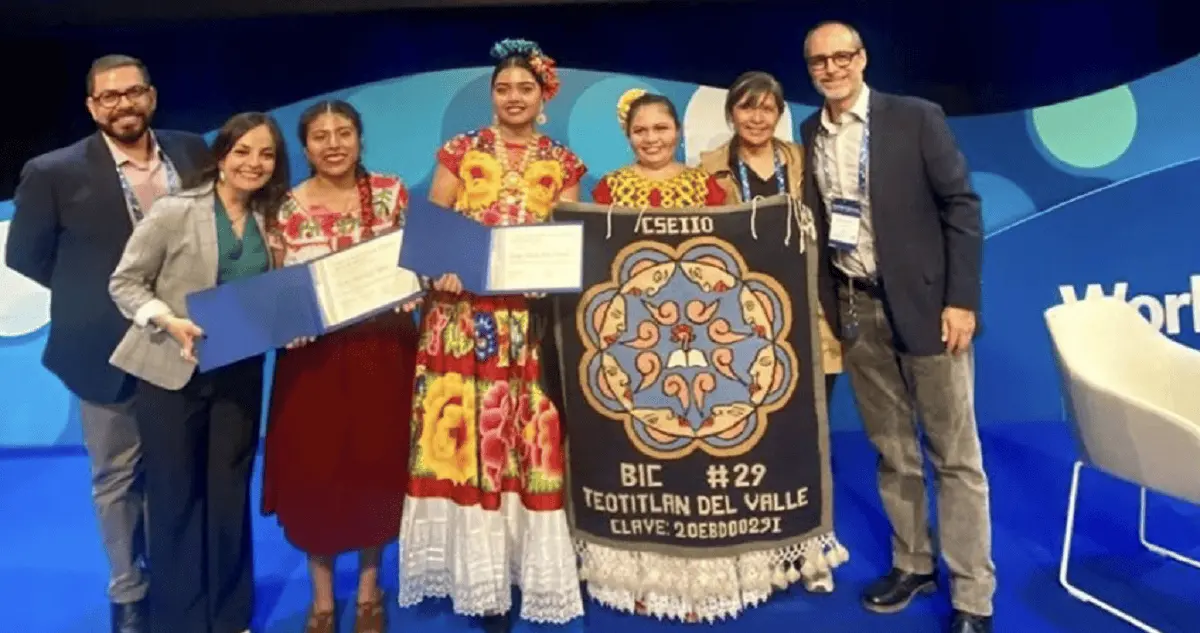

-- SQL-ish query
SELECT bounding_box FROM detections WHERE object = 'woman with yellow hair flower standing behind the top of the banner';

[592,90,725,209]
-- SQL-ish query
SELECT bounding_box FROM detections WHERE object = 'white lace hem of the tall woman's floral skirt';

[400,493,583,625]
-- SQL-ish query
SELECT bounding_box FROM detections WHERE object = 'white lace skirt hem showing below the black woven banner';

[576,533,850,622]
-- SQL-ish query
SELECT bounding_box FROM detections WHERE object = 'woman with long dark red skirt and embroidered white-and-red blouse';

[263,101,416,633]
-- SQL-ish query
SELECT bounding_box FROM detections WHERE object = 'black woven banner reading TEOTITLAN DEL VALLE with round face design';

[554,197,844,615]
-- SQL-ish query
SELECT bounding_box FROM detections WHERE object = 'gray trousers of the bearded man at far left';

[79,398,148,604]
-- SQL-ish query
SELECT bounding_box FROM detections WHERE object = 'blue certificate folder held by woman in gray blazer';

[180,231,419,372]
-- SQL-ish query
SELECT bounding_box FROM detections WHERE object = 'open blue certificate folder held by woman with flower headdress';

[400,203,583,295]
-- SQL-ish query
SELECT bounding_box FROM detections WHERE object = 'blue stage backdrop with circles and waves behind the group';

[0,58,1200,447]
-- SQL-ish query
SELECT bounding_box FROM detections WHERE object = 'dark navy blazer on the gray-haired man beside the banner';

[800,90,983,356]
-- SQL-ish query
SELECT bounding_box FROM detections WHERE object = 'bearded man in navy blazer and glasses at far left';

[5,55,210,633]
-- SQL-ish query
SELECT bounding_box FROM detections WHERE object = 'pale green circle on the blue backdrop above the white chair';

[1030,85,1138,169]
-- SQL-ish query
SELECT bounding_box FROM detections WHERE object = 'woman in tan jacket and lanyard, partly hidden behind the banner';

[700,71,842,593]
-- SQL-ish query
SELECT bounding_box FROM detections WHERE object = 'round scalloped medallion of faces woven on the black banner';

[576,237,799,459]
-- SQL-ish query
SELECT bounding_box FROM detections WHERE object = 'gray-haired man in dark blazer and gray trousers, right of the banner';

[800,23,996,633]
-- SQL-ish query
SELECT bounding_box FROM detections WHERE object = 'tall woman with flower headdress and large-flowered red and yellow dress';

[400,40,587,628]
